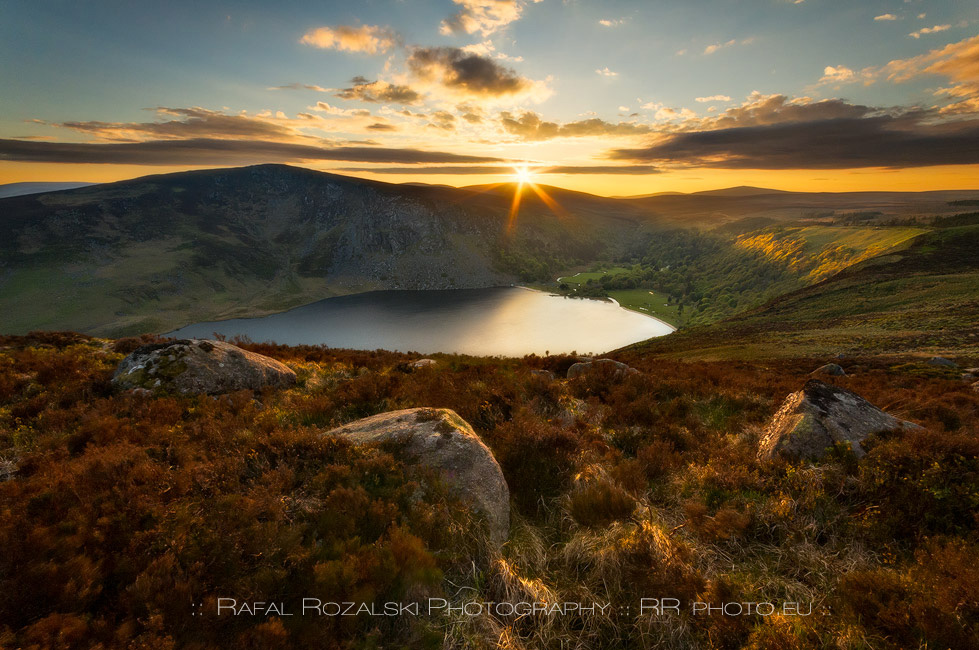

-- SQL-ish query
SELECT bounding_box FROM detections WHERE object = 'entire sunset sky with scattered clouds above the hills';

[0,0,979,196]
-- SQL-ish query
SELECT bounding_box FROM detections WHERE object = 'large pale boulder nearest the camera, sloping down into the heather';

[325,408,510,545]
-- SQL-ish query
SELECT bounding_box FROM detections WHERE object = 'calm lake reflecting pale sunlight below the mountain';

[170,287,673,356]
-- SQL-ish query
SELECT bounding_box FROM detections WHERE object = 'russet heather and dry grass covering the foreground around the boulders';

[0,333,979,649]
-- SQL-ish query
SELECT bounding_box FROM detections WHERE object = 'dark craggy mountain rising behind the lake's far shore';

[0,165,654,335]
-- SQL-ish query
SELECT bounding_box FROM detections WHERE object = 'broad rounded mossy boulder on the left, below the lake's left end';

[112,339,296,395]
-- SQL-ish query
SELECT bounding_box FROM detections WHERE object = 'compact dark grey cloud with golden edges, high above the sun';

[408,47,533,96]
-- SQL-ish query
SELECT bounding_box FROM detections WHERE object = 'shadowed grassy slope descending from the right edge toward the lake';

[632,226,979,358]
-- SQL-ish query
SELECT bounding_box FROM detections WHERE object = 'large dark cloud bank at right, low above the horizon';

[608,95,979,169]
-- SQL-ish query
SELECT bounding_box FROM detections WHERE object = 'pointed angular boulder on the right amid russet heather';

[758,379,920,460]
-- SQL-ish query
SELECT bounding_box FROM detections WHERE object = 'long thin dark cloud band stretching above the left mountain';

[0,138,502,165]
